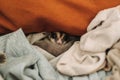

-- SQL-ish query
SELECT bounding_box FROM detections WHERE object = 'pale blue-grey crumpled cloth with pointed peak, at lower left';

[0,29,109,80]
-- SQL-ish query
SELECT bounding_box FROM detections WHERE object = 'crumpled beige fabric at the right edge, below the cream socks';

[106,41,120,80]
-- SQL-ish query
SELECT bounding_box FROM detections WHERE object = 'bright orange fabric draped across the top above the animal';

[0,0,120,35]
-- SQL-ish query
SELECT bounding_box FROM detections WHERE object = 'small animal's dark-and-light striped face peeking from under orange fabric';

[49,32,70,45]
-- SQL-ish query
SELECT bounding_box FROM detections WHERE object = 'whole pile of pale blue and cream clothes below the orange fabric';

[0,6,120,80]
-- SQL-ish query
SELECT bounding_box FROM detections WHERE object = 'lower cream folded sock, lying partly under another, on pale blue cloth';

[57,41,105,76]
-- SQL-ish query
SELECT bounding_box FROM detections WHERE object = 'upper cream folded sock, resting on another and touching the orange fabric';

[80,6,120,52]
